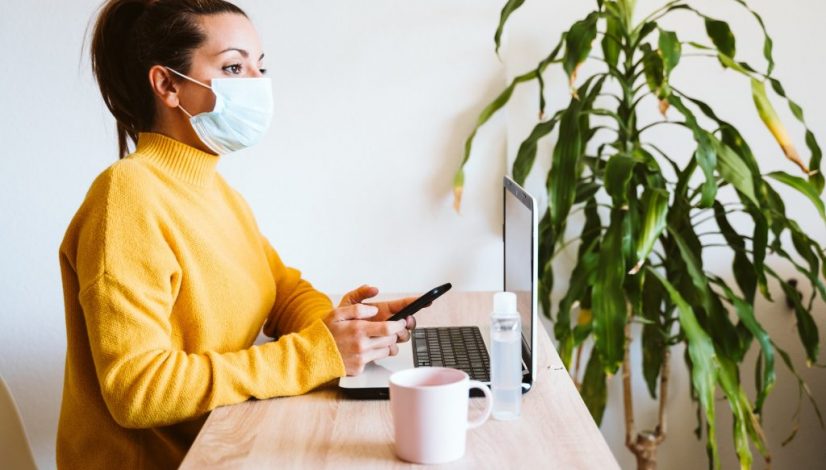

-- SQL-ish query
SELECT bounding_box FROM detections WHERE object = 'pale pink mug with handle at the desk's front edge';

[390,367,493,464]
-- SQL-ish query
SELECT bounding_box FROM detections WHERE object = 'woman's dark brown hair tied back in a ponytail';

[91,0,246,158]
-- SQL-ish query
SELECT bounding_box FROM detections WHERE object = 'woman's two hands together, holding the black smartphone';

[324,286,415,375]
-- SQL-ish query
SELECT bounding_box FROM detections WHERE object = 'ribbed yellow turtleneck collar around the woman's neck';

[134,132,220,186]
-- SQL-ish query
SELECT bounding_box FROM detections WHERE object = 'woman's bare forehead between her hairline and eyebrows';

[198,13,263,59]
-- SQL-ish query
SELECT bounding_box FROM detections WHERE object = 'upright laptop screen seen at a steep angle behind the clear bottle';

[503,178,536,382]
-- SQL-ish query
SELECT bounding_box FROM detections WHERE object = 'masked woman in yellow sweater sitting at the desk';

[57,0,415,468]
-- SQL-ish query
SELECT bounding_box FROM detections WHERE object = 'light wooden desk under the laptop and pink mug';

[181,292,619,470]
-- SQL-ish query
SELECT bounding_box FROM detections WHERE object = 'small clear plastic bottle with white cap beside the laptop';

[490,292,522,420]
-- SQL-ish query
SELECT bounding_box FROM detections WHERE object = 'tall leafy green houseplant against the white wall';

[454,0,826,468]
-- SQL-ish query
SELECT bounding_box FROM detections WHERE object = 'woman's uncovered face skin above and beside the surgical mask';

[178,13,266,115]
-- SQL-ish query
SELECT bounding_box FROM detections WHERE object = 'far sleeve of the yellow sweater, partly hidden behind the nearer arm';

[262,237,333,338]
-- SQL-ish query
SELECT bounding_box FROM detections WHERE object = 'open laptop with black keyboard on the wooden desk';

[339,176,540,399]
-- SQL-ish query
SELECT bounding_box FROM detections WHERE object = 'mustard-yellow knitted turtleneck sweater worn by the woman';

[57,133,345,469]
